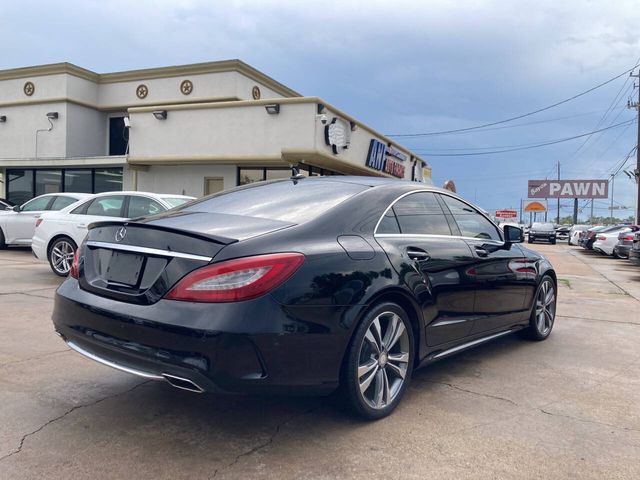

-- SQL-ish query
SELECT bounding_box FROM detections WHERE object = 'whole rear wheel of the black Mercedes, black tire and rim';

[340,302,415,420]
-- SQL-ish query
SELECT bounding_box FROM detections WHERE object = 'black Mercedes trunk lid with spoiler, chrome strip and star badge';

[78,212,292,304]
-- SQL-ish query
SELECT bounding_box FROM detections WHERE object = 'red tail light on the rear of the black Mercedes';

[165,253,304,303]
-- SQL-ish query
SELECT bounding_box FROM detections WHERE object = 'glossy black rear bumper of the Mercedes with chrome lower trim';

[53,279,349,394]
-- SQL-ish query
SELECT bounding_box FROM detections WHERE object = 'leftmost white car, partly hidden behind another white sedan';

[0,192,91,248]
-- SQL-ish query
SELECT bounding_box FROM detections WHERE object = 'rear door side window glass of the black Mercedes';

[377,192,451,235]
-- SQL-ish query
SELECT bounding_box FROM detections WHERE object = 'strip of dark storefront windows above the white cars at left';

[7,168,122,205]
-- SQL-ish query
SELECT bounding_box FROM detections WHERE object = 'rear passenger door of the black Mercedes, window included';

[375,191,474,346]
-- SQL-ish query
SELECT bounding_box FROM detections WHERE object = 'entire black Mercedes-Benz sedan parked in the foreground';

[53,176,557,419]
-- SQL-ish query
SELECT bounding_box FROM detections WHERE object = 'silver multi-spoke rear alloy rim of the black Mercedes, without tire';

[357,311,410,410]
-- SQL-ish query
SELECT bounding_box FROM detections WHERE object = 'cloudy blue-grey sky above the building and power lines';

[0,0,640,219]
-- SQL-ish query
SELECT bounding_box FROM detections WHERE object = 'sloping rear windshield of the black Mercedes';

[182,180,367,224]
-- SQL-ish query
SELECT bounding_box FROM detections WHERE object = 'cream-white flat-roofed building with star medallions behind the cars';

[0,60,431,203]
